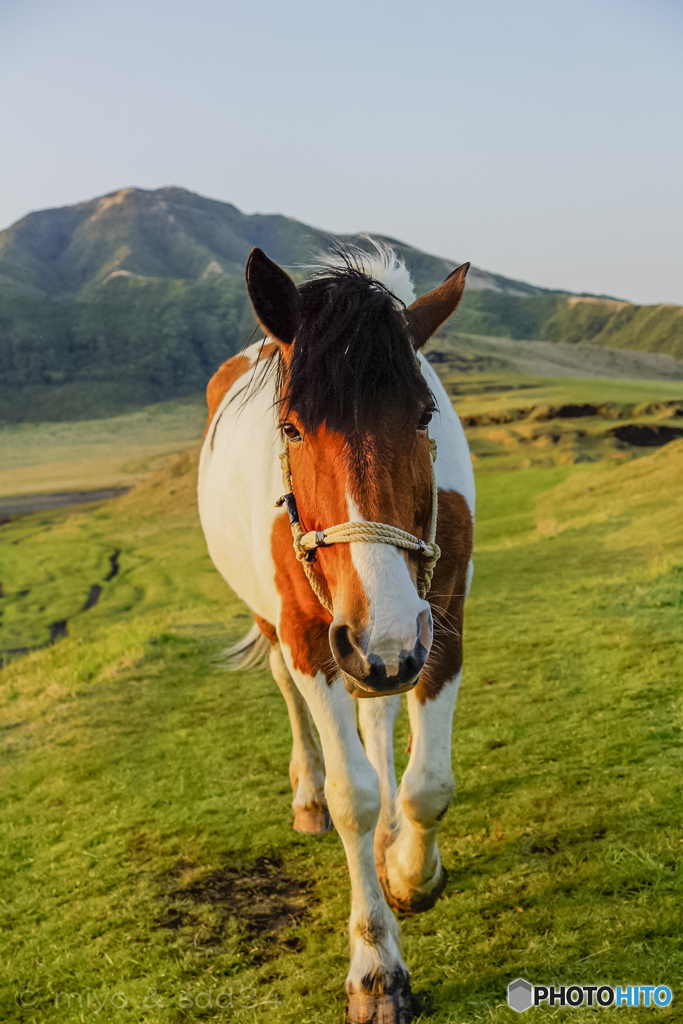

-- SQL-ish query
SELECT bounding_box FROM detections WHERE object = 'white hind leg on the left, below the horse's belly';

[270,644,332,835]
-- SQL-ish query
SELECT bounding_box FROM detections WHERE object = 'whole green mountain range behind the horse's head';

[0,187,683,422]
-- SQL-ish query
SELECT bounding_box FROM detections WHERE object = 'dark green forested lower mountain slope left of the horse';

[0,275,254,422]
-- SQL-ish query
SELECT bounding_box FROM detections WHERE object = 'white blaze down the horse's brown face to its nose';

[346,495,432,676]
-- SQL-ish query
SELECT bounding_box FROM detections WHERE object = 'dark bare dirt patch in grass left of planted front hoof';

[156,857,316,962]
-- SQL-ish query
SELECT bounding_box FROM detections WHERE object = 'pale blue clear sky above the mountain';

[0,0,683,304]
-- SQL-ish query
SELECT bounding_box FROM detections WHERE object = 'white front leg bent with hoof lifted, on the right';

[386,673,461,912]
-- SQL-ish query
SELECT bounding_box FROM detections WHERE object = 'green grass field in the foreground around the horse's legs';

[0,368,683,1024]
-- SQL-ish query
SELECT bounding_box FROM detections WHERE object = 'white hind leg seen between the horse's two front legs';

[358,693,400,877]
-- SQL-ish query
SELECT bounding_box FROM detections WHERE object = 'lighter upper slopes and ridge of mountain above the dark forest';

[0,188,545,296]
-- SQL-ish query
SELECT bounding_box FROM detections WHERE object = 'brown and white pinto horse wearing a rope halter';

[199,244,474,1024]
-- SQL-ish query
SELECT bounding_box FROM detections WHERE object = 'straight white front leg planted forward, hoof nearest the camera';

[283,647,411,1024]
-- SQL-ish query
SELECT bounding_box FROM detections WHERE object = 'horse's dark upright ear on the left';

[246,249,301,345]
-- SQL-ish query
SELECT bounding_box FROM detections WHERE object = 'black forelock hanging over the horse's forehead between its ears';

[281,258,433,434]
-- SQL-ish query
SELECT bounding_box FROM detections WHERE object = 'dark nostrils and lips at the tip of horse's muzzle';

[330,616,431,697]
